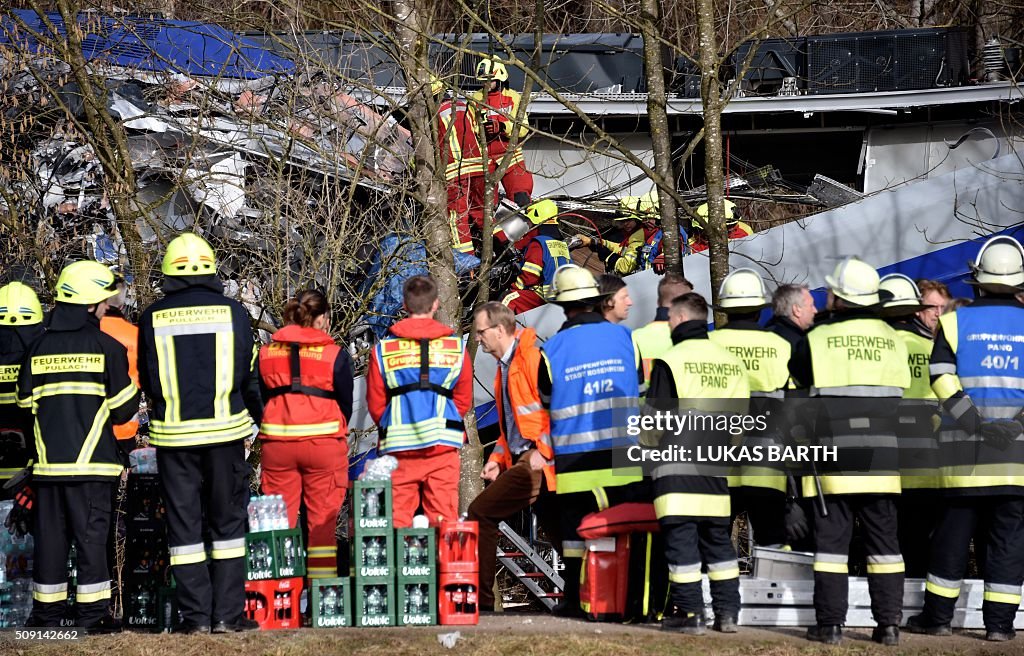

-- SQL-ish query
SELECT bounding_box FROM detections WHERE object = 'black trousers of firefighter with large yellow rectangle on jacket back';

[157,440,249,625]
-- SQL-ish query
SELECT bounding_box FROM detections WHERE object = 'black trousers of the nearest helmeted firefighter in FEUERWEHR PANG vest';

[814,494,904,626]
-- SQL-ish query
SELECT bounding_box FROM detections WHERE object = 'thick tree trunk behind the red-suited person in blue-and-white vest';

[393,0,489,509]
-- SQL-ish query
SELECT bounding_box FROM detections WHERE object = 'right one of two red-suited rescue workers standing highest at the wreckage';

[473,58,534,208]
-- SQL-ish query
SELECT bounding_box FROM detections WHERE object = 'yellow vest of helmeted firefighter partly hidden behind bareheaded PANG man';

[708,320,792,492]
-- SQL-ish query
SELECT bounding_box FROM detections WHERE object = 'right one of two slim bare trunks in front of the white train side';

[697,0,729,325]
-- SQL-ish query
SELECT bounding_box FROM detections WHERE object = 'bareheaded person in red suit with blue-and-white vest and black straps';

[367,275,473,528]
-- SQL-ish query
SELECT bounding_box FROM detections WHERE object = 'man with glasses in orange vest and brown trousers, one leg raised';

[469,301,559,611]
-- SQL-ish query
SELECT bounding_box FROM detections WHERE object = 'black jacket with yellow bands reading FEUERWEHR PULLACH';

[17,303,139,482]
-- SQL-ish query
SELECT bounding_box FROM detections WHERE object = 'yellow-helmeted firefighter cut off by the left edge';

[0,282,43,491]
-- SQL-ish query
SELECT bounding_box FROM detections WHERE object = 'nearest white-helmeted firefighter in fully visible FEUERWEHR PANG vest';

[790,257,910,645]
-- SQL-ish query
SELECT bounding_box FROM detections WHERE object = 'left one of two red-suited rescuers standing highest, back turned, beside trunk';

[430,78,489,253]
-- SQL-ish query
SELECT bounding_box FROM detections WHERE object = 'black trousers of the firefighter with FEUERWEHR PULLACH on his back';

[31,478,114,627]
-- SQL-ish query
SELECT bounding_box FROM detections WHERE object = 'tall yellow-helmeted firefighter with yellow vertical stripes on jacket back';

[138,232,263,633]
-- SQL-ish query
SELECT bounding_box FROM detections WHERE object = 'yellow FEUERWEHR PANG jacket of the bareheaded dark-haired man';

[647,320,751,519]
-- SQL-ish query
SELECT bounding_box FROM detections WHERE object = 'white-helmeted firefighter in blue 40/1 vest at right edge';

[907,235,1024,642]
